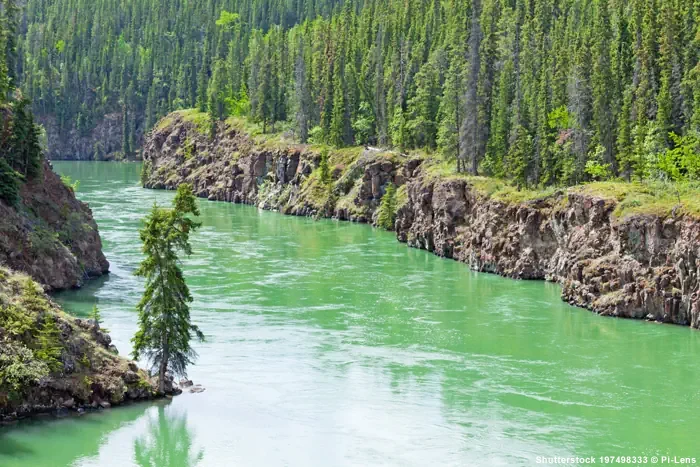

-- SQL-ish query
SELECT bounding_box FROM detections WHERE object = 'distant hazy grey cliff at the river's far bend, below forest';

[38,112,142,161]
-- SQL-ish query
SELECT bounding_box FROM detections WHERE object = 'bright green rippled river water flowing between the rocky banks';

[0,162,700,467]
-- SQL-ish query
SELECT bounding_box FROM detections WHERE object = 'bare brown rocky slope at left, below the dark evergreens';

[0,164,109,289]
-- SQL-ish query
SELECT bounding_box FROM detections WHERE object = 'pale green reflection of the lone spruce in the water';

[134,405,204,467]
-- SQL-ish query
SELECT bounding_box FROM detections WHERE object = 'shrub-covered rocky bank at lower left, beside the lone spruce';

[0,267,161,422]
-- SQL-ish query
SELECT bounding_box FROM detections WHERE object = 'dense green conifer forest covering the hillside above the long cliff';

[13,0,700,186]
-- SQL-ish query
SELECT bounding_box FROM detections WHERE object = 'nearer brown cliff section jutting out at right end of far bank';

[397,174,700,328]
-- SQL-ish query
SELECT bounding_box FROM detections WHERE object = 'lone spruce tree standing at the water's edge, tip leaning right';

[132,185,204,392]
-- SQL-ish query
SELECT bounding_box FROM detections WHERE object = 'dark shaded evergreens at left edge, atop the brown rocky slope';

[0,0,42,205]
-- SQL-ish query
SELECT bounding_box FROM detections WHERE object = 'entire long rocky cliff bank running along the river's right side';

[143,112,700,328]
